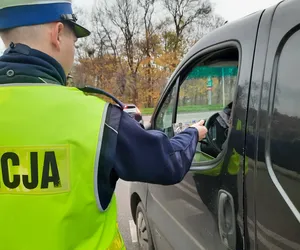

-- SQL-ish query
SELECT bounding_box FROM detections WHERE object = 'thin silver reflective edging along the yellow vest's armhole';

[94,103,108,212]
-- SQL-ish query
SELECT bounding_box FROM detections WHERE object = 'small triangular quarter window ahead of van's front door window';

[154,84,177,137]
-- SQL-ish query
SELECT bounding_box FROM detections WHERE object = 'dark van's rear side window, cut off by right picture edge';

[267,31,300,211]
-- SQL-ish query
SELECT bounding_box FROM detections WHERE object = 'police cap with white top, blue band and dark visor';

[0,0,90,38]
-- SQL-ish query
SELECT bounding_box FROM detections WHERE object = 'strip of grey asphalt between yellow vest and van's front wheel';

[116,180,138,250]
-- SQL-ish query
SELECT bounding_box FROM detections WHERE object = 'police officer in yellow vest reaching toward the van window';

[0,0,207,250]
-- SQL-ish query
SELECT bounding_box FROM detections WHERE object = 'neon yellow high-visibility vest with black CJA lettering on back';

[0,84,125,250]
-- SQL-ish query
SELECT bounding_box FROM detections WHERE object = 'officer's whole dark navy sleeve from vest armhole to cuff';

[98,105,198,208]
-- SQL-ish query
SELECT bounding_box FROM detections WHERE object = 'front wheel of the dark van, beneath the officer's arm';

[135,202,154,250]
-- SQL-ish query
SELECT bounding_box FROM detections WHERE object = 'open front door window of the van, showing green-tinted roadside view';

[155,48,239,163]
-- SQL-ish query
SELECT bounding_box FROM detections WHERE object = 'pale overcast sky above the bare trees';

[0,0,280,51]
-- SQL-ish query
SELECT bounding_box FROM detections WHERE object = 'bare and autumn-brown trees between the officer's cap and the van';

[72,0,224,107]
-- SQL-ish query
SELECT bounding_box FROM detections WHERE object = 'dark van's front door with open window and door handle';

[147,9,261,250]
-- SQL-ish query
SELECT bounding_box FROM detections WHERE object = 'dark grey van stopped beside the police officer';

[130,0,300,250]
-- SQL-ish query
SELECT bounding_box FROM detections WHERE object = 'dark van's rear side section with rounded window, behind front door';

[246,0,300,250]
